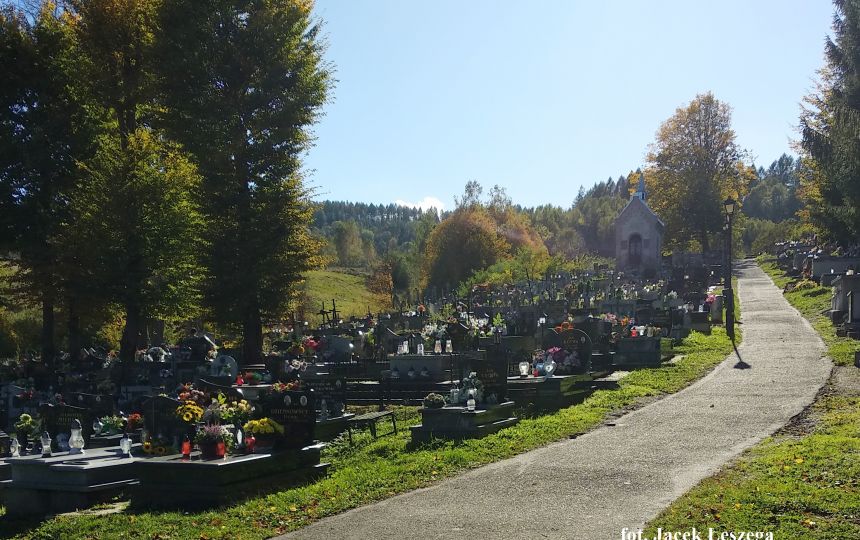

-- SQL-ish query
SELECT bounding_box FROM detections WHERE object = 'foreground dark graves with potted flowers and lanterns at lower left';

[0,350,354,515]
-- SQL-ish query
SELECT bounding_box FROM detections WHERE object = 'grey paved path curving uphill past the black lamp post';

[286,262,831,540]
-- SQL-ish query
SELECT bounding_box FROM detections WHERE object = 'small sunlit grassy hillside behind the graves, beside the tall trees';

[304,270,391,325]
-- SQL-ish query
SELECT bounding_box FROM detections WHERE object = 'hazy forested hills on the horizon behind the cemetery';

[312,154,801,298]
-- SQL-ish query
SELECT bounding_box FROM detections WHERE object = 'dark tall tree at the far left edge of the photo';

[0,2,96,362]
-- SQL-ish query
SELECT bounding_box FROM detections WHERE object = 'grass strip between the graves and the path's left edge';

[0,327,731,540]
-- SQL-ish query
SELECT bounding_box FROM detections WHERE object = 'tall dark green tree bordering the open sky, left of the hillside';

[159,0,332,361]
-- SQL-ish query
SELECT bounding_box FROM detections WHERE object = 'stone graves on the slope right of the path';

[774,242,860,367]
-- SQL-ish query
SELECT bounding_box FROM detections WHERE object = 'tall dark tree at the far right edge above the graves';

[800,0,860,242]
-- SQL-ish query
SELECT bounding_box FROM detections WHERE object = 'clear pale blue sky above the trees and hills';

[305,0,833,209]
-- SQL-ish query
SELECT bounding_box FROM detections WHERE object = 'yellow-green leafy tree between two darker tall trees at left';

[70,0,202,360]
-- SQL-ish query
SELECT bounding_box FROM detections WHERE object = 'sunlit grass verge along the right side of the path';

[645,260,860,540]
